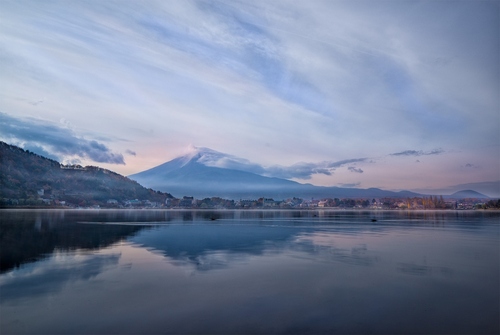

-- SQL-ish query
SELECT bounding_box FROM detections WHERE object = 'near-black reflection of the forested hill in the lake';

[0,211,150,272]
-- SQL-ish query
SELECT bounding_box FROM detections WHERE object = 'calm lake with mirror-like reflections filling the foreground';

[0,210,500,334]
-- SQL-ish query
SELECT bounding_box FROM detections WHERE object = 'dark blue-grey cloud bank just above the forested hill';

[0,113,125,164]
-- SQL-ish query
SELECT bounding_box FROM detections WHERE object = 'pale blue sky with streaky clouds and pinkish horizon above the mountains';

[0,0,500,190]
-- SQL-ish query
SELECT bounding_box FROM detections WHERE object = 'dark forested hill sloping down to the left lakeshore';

[0,141,172,206]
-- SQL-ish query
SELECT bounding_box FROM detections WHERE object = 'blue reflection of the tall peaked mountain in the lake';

[131,223,383,271]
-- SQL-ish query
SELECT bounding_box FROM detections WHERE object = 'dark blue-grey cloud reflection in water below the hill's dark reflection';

[0,253,120,302]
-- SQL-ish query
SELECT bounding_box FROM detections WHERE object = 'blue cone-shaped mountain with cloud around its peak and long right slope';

[129,147,418,200]
